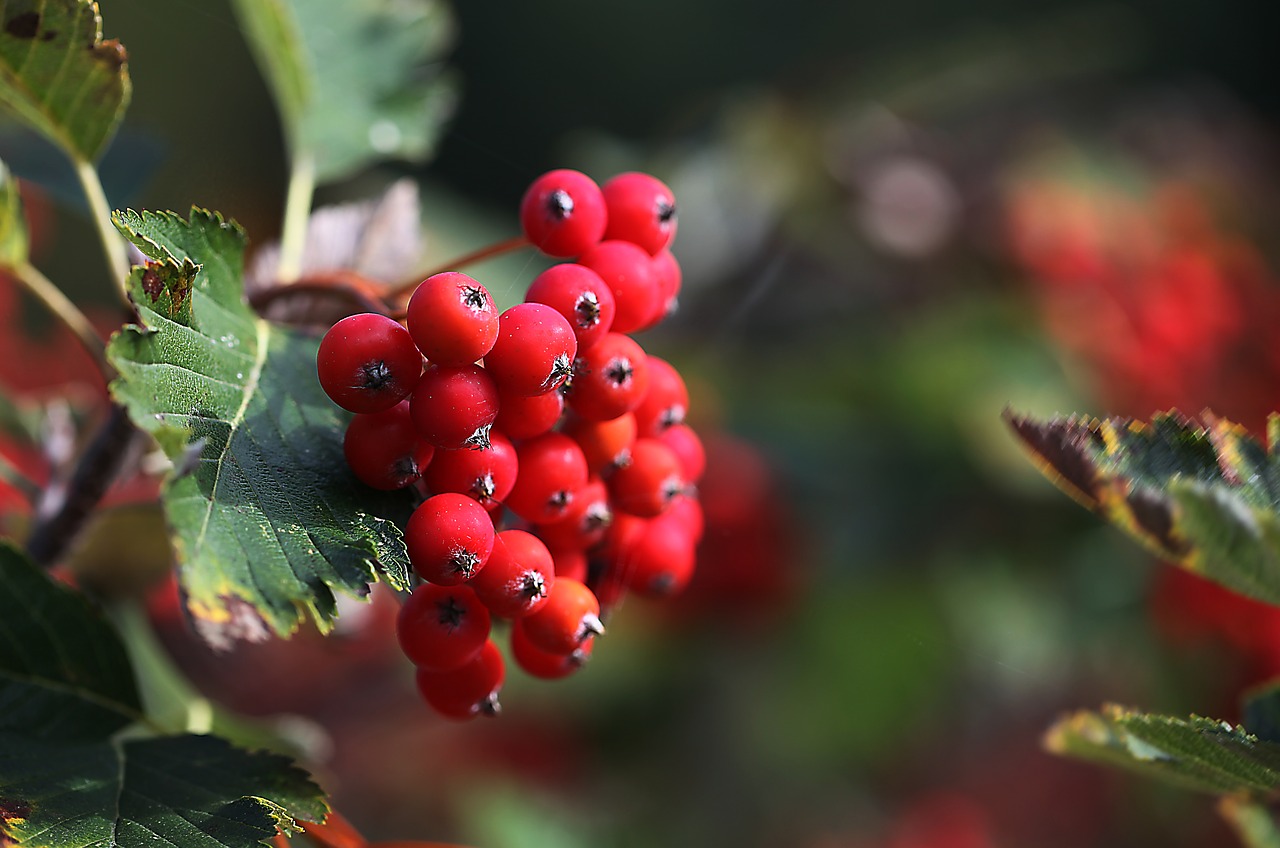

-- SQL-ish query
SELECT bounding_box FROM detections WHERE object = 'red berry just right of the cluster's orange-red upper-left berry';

[484,304,577,395]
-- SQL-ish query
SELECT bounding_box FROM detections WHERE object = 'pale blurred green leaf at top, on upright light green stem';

[233,0,454,182]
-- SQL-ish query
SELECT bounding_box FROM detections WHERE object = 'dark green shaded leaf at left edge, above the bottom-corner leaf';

[0,543,142,740]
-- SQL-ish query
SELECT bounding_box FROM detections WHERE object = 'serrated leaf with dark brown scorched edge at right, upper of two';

[1005,412,1280,603]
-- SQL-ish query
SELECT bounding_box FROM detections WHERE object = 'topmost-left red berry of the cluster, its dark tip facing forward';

[520,169,607,256]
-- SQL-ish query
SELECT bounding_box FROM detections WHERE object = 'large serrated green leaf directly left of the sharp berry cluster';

[108,209,408,644]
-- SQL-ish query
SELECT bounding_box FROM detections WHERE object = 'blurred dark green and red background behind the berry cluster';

[5,0,1280,848]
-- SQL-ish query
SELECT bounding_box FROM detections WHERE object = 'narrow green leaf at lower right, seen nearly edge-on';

[1044,705,1280,794]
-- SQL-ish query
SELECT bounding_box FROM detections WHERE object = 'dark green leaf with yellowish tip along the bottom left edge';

[0,731,326,848]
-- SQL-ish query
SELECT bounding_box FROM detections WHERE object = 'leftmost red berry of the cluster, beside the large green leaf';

[316,313,422,412]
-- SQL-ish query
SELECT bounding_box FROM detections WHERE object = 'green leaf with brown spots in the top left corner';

[0,0,131,163]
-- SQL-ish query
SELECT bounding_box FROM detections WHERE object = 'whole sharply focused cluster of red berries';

[317,170,705,719]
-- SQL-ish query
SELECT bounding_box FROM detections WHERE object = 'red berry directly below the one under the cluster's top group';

[568,333,649,421]
